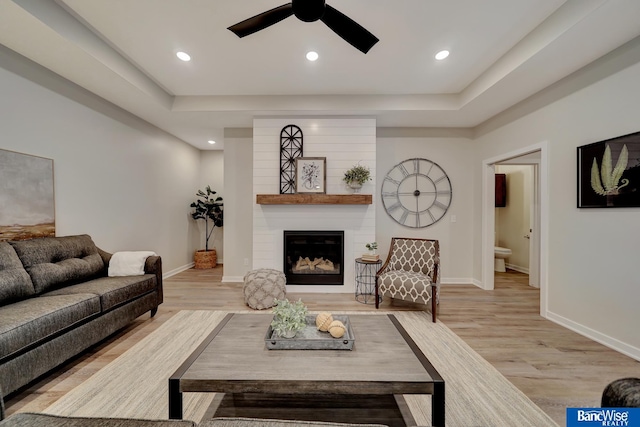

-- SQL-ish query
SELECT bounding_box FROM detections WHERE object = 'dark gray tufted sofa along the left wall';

[0,235,162,399]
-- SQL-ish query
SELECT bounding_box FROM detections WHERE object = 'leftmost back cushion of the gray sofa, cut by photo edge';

[0,242,35,306]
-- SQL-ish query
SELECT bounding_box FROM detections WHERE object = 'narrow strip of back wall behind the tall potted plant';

[200,150,226,264]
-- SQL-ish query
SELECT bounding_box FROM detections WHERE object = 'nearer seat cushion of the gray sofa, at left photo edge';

[0,294,100,359]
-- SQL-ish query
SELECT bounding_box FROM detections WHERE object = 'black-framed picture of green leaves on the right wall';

[578,132,640,208]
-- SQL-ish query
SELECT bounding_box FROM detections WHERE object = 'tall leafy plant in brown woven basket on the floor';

[191,185,224,268]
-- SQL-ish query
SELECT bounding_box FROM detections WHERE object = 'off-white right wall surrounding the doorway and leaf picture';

[474,45,640,359]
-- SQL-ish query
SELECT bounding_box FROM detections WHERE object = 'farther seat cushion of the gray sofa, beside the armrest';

[43,274,157,311]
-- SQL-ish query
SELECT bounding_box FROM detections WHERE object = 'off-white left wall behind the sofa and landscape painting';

[0,55,200,273]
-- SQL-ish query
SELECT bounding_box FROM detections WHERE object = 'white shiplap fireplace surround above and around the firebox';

[253,117,378,293]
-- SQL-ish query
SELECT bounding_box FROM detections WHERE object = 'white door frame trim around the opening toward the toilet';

[482,142,548,317]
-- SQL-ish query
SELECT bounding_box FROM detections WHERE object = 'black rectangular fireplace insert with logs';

[283,230,344,285]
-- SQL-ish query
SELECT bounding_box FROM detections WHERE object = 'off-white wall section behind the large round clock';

[376,129,474,283]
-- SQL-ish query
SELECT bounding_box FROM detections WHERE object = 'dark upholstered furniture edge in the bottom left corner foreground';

[0,412,196,427]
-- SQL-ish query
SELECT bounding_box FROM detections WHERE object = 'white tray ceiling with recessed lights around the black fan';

[0,0,640,149]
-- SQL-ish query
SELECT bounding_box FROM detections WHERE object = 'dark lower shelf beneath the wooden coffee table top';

[205,393,416,427]
